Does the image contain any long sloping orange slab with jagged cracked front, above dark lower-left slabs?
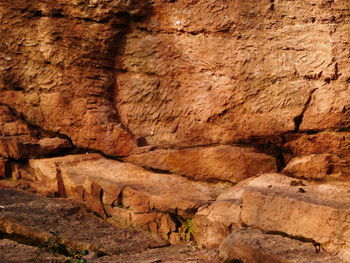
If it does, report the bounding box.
[13,154,222,243]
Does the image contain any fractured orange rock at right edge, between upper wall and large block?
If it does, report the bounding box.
[283,131,350,180]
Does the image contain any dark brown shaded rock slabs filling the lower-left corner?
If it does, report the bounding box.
[0,189,218,263]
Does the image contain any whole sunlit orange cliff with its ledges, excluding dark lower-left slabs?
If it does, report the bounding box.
[0,0,350,263]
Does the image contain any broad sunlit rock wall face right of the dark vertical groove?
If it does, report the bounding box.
[115,0,350,146]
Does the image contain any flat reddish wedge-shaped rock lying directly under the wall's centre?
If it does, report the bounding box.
[126,145,277,183]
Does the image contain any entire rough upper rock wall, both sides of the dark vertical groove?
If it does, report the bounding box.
[0,0,350,156]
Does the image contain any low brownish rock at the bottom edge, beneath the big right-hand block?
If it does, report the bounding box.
[220,229,345,263]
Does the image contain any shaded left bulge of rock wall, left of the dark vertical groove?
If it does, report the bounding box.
[0,0,145,155]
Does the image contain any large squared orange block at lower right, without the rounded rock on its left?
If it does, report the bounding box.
[240,174,350,260]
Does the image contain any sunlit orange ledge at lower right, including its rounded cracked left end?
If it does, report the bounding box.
[194,174,350,260]
